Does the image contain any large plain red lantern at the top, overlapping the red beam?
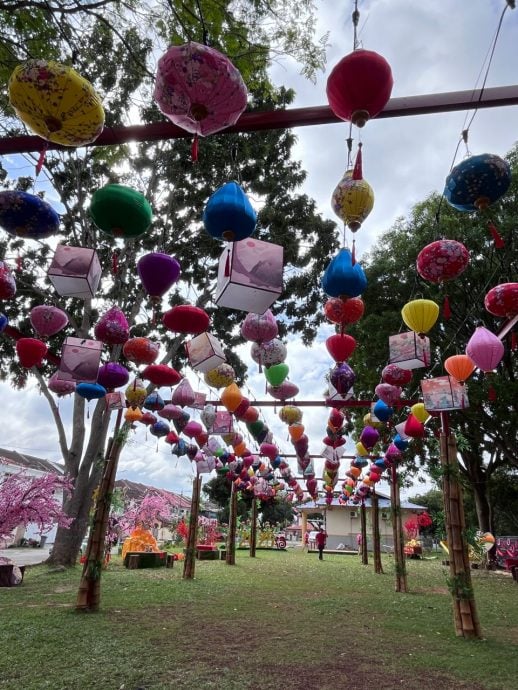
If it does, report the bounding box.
[326,49,394,127]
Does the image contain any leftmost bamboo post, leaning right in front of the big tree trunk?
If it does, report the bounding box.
[76,409,124,611]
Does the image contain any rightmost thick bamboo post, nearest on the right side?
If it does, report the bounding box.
[440,412,482,639]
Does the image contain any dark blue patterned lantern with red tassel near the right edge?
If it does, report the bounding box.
[444,153,511,211]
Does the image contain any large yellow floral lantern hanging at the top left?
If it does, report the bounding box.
[8,60,104,146]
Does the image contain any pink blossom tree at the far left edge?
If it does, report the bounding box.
[0,471,73,539]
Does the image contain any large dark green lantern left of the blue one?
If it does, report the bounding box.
[90,184,153,239]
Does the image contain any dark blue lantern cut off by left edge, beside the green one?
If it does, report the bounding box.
[0,189,59,240]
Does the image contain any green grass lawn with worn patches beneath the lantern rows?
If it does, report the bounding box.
[0,550,518,690]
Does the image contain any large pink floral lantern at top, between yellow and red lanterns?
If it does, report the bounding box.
[153,41,247,136]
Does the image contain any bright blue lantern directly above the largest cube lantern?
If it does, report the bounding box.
[203,182,257,242]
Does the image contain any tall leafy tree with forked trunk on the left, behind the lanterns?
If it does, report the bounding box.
[0,0,336,564]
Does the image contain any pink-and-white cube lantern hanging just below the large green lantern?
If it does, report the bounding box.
[47,244,102,299]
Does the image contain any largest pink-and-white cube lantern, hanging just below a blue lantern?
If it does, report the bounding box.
[215,238,283,314]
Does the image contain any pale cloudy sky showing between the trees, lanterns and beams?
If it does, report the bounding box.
[0,0,518,495]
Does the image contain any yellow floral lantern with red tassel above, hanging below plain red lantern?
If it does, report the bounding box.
[331,149,374,232]
